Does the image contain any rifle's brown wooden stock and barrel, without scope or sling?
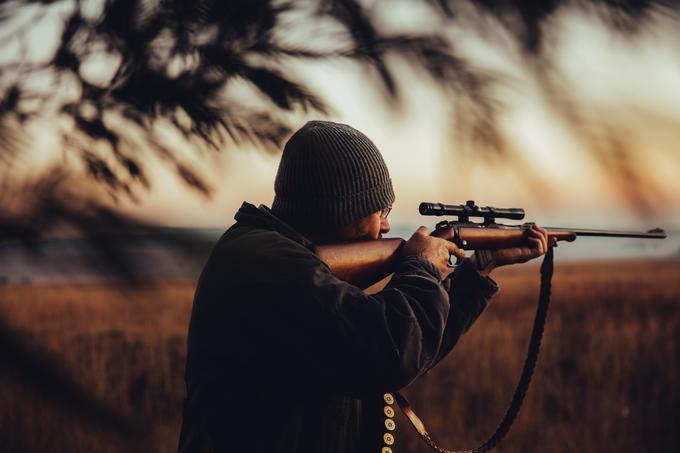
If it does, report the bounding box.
[316,222,666,288]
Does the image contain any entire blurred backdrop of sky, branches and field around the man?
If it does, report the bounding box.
[0,0,680,452]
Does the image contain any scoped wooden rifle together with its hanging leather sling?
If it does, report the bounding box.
[316,201,666,453]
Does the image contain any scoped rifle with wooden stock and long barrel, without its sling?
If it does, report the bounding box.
[316,200,666,288]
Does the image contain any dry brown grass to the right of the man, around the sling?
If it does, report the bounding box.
[400,262,680,453]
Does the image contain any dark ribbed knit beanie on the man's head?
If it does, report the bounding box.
[272,121,394,231]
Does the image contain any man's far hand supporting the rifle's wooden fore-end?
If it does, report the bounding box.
[470,225,555,276]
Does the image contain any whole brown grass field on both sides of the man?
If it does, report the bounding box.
[0,260,680,453]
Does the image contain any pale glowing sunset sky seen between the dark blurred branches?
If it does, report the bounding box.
[0,2,680,237]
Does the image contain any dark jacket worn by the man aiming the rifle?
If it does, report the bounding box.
[180,203,497,453]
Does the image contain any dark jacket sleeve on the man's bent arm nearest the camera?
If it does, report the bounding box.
[298,257,449,395]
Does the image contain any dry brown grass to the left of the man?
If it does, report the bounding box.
[0,281,193,452]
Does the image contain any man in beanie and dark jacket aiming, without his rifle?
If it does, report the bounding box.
[180,121,547,453]
